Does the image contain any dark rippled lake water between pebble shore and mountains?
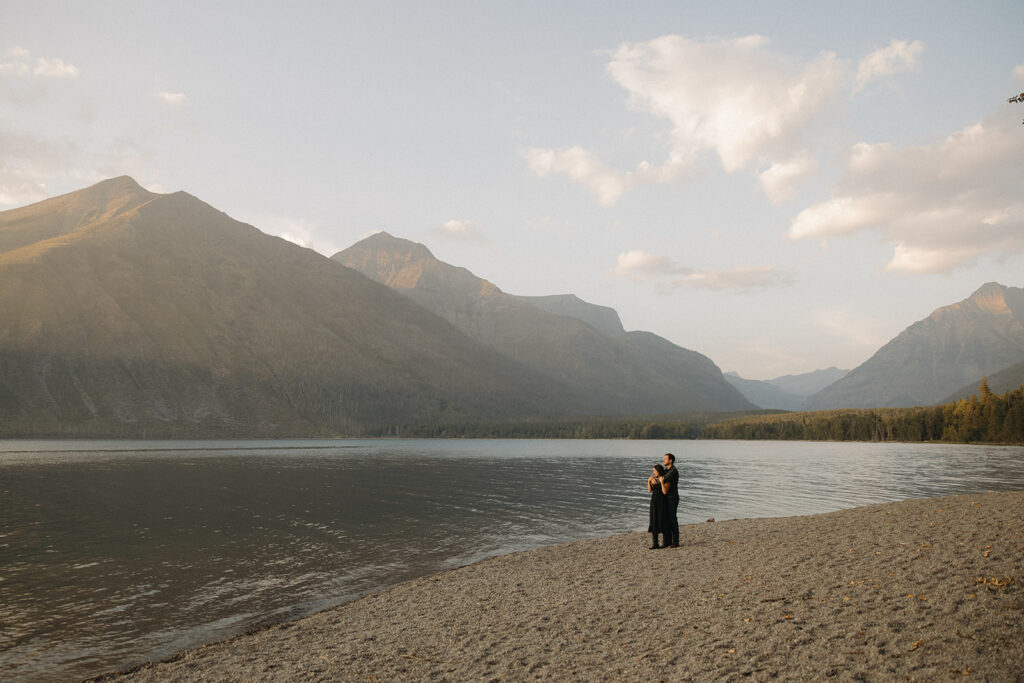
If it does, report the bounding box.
[6,440,1024,681]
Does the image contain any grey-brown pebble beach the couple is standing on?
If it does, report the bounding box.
[97,492,1024,681]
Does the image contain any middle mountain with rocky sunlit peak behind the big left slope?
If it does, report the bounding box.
[332,232,753,415]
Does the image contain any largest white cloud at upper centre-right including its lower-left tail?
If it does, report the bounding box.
[524,36,853,205]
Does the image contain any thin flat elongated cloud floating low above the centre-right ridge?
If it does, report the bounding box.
[612,251,793,291]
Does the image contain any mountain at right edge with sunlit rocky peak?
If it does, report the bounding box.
[804,283,1024,410]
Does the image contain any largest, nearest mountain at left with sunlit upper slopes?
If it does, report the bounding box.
[0,177,585,436]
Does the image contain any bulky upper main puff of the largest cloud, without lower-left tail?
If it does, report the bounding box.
[607,36,849,172]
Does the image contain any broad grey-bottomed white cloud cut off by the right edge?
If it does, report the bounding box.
[790,109,1024,272]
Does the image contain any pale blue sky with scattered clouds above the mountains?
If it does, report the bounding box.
[0,0,1024,379]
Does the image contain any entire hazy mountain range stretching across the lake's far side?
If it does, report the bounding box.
[0,177,1024,437]
